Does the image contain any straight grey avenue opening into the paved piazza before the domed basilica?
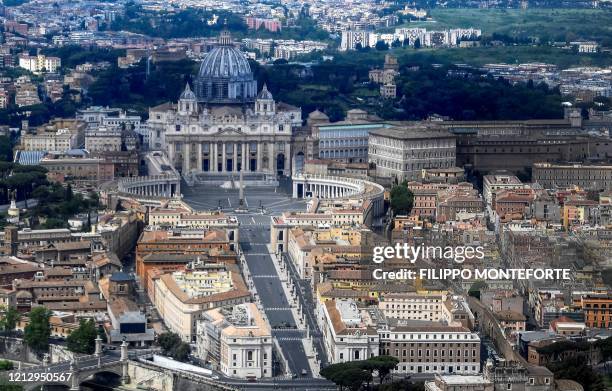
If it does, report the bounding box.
[182,185,330,382]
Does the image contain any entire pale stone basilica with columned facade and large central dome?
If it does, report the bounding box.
[147,31,304,175]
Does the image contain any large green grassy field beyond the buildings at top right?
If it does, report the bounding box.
[405,8,612,46]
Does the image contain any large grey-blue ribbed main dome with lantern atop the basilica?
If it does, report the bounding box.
[194,30,257,103]
